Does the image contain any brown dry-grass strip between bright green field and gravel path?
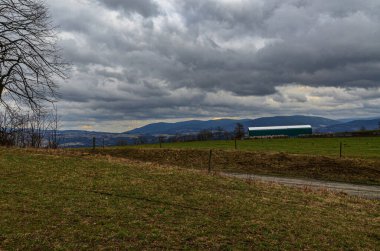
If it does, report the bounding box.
[92,148,380,185]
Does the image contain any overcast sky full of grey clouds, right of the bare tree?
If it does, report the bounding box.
[45,0,380,132]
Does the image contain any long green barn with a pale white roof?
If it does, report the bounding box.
[248,125,313,137]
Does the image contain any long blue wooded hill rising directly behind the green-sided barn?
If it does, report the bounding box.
[126,115,341,135]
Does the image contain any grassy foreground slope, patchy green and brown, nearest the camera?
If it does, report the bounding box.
[0,149,380,250]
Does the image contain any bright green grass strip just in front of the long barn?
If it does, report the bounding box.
[127,137,380,159]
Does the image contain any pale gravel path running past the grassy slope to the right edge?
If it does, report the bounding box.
[221,173,380,200]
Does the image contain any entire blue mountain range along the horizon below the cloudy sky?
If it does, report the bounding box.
[59,115,380,147]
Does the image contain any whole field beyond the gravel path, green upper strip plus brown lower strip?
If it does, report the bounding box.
[92,137,380,185]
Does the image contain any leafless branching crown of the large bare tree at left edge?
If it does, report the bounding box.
[0,0,68,110]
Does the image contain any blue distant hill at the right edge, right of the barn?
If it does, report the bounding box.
[318,118,380,133]
